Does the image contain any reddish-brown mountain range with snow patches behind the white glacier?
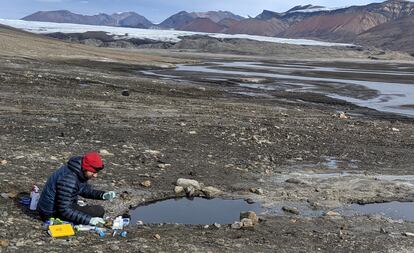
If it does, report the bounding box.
[23,0,414,52]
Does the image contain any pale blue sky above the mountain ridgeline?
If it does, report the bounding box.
[0,0,392,23]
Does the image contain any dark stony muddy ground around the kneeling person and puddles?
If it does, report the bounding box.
[0,26,414,252]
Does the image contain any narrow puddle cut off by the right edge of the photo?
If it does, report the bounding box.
[339,201,414,221]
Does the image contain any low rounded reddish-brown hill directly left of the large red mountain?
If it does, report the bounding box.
[226,18,288,36]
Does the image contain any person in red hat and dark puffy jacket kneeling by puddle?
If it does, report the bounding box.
[37,152,116,226]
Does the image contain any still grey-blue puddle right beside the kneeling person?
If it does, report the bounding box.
[130,198,264,225]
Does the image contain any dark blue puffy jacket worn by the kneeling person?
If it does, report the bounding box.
[38,156,104,224]
